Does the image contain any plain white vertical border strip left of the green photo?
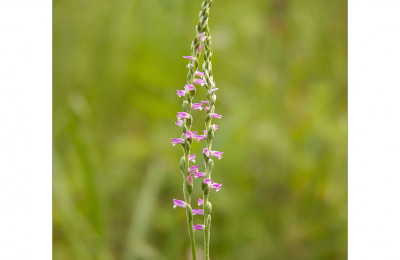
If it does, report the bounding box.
[0,0,52,260]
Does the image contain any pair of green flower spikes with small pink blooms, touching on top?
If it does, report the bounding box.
[171,0,219,259]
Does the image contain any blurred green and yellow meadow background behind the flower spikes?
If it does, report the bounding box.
[53,0,347,260]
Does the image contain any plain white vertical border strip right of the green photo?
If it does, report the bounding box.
[348,0,400,260]
